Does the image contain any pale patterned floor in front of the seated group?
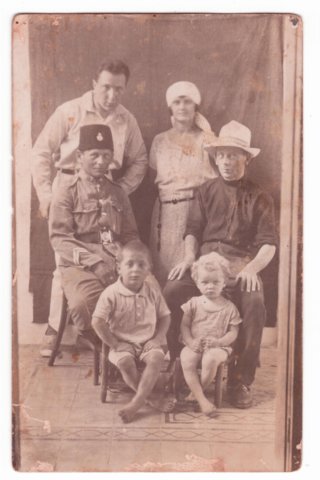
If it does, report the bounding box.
[15,345,276,472]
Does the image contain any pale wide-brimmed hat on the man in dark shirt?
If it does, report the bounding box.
[204,120,260,158]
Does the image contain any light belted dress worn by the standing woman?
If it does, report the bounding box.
[150,130,217,286]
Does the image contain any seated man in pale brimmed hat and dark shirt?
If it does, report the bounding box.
[164,121,277,408]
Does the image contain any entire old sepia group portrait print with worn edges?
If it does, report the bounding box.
[12,13,302,472]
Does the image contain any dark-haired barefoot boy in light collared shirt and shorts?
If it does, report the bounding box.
[92,240,174,422]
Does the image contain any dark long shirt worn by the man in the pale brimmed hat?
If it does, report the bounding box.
[184,177,277,258]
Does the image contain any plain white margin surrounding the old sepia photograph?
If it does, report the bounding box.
[0,0,320,479]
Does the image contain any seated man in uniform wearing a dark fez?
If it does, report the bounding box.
[49,124,138,343]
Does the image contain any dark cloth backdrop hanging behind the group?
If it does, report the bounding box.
[29,14,282,326]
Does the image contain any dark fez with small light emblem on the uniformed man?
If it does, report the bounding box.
[78,125,113,152]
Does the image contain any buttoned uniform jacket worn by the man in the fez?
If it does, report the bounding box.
[49,170,138,269]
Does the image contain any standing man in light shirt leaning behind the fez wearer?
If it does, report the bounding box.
[31,60,147,356]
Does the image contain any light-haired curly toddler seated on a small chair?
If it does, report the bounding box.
[181,252,241,417]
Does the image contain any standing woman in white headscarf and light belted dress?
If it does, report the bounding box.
[150,81,216,286]
